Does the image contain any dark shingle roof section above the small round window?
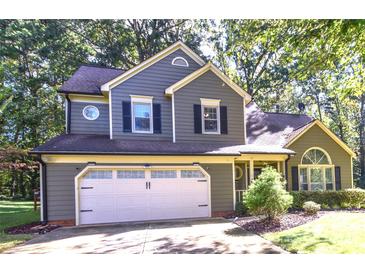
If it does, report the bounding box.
[59,65,124,95]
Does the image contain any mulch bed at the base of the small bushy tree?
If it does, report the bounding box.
[235,211,326,234]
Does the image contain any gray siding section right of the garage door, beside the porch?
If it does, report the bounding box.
[202,164,233,213]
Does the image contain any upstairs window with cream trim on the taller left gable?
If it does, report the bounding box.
[131,95,153,133]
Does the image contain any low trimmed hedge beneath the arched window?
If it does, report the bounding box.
[290,188,365,209]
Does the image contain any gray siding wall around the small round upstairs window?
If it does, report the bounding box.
[71,102,109,135]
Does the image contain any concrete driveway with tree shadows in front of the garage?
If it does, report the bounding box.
[5,219,285,254]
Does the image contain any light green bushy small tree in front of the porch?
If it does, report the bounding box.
[245,166,293,220]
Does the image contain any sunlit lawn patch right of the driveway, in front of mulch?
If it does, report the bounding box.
[264,212,365,254]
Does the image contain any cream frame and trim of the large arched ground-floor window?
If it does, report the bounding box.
[298,147,336,191]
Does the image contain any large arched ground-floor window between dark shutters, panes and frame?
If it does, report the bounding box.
[299,147,335,191]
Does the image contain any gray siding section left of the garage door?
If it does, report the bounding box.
[47,164,85,221]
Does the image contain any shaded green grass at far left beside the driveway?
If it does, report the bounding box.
[0,201,39,253]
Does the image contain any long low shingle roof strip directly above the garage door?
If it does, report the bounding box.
[32,134,294,155]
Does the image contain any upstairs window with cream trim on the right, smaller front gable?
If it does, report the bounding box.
[200,98,221,134]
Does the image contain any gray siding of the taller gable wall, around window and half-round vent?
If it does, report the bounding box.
[111,50,200,140]
